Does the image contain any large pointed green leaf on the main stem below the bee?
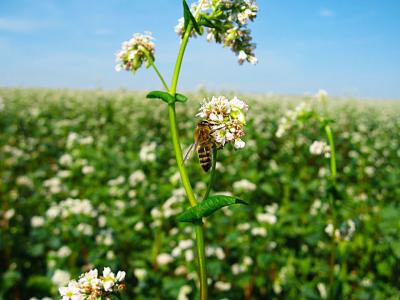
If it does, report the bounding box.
[177,195,247,222]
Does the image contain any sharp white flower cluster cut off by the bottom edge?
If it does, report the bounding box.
[59,268,126,300]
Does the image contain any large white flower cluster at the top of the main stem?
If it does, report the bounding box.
[175,0,258,64]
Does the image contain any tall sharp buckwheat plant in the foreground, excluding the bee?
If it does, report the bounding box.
[116,0,258,300]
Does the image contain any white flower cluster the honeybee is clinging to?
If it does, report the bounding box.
[196,96,249,149]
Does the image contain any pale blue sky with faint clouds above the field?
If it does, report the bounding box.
[0,0,400,99]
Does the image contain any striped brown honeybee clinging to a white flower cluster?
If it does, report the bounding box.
[184,121,224,172]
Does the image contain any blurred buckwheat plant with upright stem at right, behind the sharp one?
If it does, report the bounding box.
[275,90,356,299]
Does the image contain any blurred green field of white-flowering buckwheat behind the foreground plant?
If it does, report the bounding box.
[0,89,400,300]
